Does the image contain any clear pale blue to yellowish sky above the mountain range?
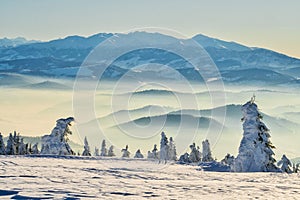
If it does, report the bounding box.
[0,0,300,58]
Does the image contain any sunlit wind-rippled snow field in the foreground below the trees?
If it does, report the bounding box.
[0,156,300,199]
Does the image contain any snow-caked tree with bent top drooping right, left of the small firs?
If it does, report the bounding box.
[41,117,74,155]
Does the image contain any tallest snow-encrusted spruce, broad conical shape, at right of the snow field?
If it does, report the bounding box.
[232,96,279,172]
